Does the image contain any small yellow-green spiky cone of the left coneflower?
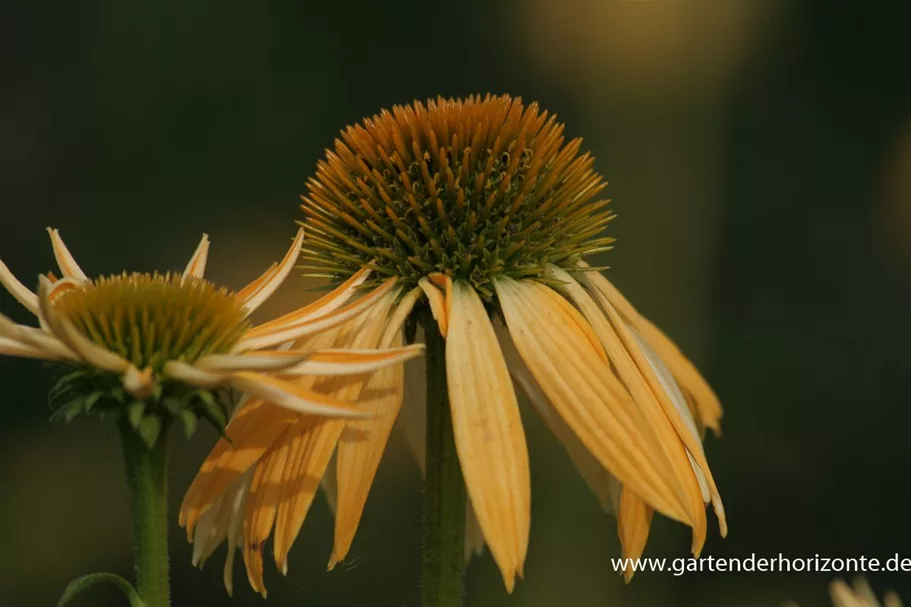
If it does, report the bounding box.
[53,273,247,371]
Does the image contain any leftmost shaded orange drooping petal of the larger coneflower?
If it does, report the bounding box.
[178,399,298,538]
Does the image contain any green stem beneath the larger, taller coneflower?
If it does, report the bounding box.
[421,320,466,607]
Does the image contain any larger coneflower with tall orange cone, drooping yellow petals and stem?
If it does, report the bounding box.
[183,96,726,606]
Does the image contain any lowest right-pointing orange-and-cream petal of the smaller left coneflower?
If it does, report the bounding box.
[230,371,368,417]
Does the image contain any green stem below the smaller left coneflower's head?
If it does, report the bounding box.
[120,424,171,607]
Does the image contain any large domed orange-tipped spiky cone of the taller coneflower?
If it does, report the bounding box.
[302,96,613,299]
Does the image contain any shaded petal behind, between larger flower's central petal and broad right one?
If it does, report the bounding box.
[494,322,619,512]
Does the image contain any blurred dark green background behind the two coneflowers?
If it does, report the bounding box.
[0,0,911,607]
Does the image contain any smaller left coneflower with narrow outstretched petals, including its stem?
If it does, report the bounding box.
[0,229,420,607]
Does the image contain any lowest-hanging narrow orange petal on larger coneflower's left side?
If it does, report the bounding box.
[243,424,296,598]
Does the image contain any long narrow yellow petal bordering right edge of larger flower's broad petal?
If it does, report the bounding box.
[548,266,707,555]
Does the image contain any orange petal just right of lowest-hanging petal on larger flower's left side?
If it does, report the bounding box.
[272,417,345,574]
